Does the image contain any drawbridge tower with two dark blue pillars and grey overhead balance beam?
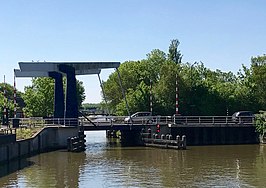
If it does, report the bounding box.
[14,62,120,126]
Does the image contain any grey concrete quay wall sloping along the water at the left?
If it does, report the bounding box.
[0,126,79,163]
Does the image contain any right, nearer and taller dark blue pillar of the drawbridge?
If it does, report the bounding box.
[59,65,78,126]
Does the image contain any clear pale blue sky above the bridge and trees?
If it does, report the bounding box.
[0,0,266,103]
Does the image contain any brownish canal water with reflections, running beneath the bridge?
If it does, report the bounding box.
[0,131,266,187]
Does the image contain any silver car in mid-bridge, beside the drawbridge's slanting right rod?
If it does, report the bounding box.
[124,112,152,124]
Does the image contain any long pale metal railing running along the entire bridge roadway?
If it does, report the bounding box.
[2,115,255,129]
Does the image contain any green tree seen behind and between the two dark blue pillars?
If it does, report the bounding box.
[23,78,85,117]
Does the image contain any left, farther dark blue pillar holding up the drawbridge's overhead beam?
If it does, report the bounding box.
[49,72,65,119]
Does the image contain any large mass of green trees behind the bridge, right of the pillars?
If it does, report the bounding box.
[101,40,266,116]
